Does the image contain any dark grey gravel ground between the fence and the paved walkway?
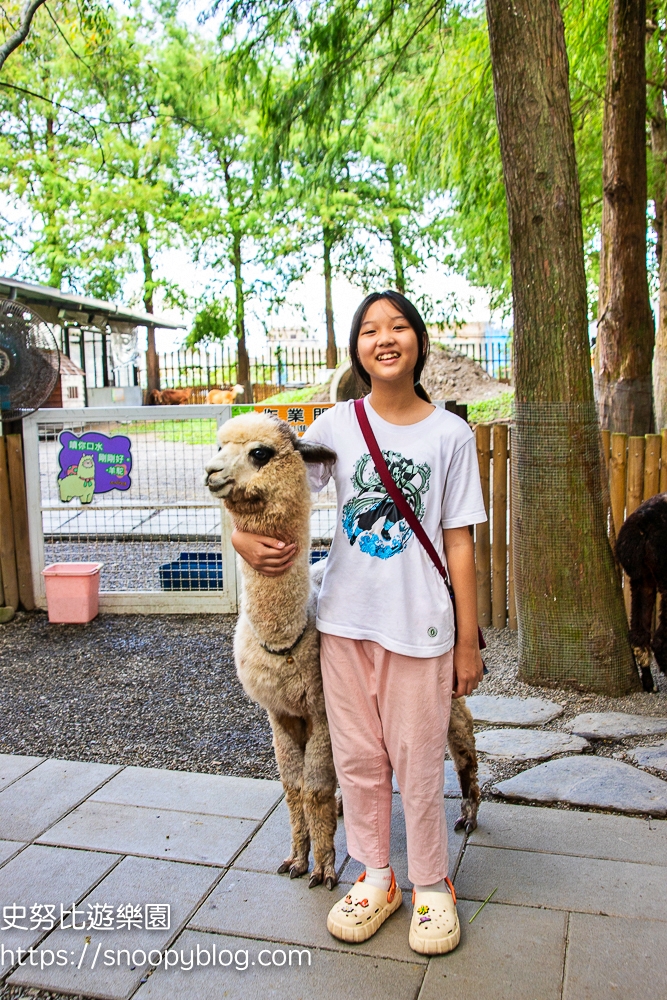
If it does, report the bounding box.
[0,613,667,1000]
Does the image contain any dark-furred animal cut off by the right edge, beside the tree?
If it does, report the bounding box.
[616,493,667,691]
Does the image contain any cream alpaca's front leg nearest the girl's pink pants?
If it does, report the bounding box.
[303,717,338,889]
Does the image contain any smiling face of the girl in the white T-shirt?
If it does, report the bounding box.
[357,299,419,382]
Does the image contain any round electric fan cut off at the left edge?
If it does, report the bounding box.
[0,298,60,421]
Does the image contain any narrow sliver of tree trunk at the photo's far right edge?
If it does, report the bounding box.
[650,32,667,430]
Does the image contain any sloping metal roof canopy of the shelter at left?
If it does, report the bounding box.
[0,276,184,330]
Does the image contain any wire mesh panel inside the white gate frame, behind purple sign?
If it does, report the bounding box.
[38,418,223,591]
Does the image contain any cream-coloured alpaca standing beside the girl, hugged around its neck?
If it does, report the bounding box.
[206,414,479,889]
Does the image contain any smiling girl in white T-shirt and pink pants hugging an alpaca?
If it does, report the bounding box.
[233,291,486,954]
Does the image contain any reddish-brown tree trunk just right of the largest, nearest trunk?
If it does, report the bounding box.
[595,0,654,434]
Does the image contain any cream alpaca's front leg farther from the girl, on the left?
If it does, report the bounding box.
[269,712,310,878]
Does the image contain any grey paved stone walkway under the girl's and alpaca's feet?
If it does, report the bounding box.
[0,755,667,1000]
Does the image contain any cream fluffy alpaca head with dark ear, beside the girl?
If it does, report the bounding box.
[205,413,336,512]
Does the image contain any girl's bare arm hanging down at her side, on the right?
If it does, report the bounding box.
[442,527,483,698]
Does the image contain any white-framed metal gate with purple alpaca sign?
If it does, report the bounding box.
[23,405,237,614]
